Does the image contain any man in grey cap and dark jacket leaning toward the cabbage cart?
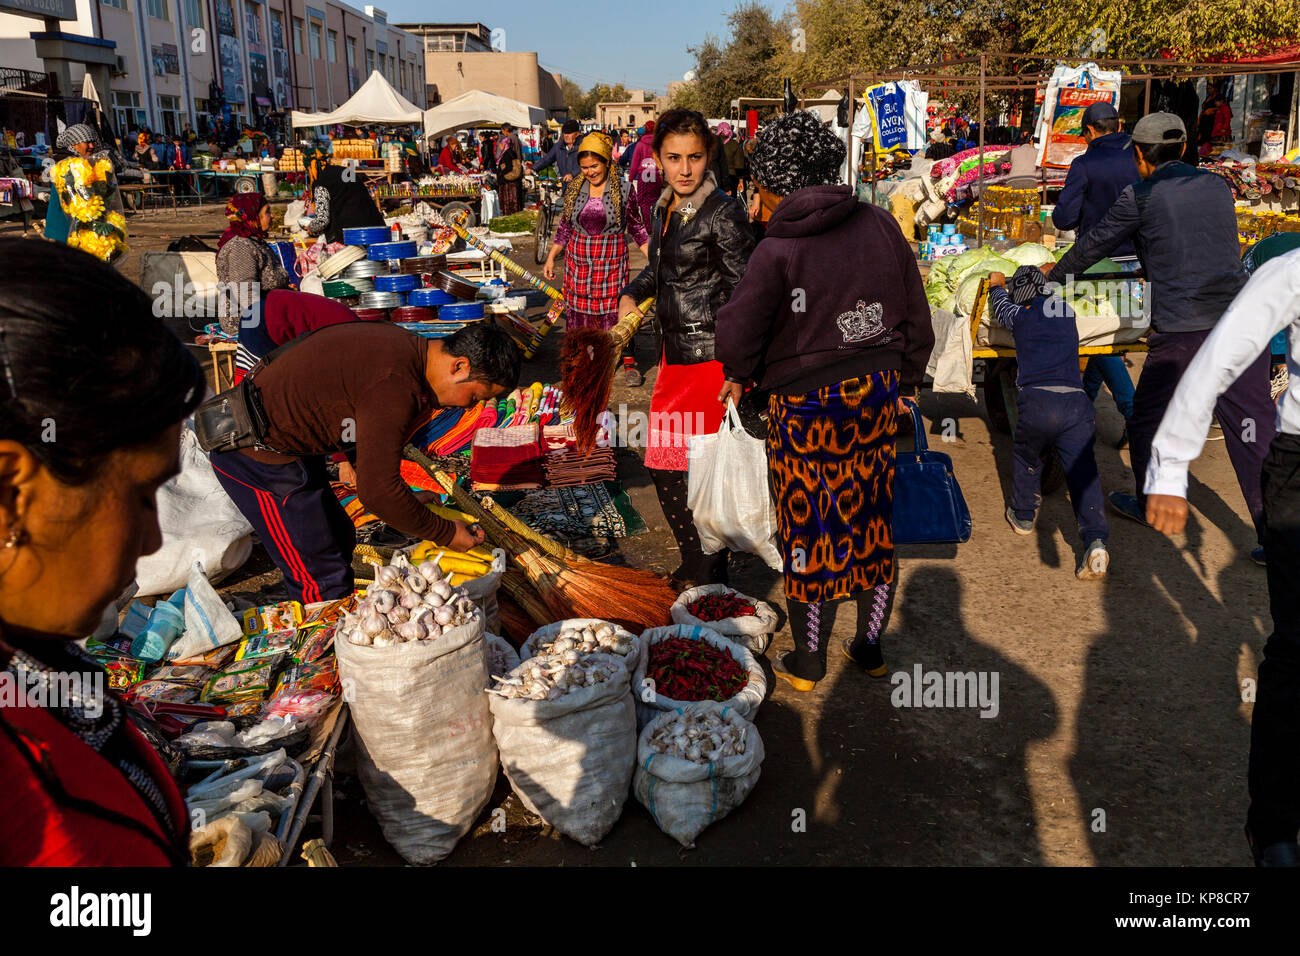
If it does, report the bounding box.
[1043,113,1275,563]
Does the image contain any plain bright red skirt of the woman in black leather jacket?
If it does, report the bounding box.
[646,352,724,471]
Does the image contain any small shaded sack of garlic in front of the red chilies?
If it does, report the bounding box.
[632,701,763,849]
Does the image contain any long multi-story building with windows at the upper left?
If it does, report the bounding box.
[0,0,426,140]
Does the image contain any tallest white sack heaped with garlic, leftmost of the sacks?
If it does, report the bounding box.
[334,564,497,865]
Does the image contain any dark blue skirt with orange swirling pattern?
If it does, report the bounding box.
[767,372,898,604]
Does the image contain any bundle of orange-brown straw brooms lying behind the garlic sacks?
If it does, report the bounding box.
[404,445,677,633]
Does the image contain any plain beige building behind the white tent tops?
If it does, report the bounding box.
[398,23,567,116]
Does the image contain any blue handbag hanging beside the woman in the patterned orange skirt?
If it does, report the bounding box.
[893,406,971,545]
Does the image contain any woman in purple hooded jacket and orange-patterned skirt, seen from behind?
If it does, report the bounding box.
[716,112,935,691]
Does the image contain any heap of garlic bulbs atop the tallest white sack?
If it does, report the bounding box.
[338,554,476,648]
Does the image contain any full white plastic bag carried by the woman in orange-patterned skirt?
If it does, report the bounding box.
[686,402,785,571]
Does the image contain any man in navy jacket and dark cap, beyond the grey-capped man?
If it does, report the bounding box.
[1052,103,1141,447]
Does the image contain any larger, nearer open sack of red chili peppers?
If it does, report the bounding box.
[632,624,767,727]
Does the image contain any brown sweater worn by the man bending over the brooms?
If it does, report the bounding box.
[244,323,455,544]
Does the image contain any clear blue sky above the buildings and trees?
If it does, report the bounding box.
[379,0,775,92]
